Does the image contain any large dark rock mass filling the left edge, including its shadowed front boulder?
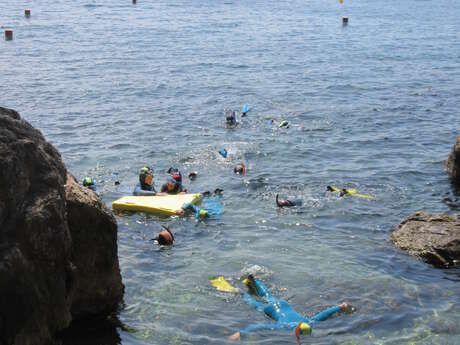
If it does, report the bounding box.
[0,107,123,345]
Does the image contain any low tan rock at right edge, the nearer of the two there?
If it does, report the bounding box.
[391,212,460,267]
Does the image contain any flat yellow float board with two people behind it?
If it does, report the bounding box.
[112,193,203,216]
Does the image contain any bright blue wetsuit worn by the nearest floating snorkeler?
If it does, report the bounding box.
[240,279,340,335]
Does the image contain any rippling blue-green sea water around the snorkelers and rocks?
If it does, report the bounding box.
[0,0,460,345]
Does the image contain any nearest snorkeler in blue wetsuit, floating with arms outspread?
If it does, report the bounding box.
[228,275,353,343]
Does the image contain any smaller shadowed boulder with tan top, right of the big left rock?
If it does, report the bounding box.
[65,174,123,319]
